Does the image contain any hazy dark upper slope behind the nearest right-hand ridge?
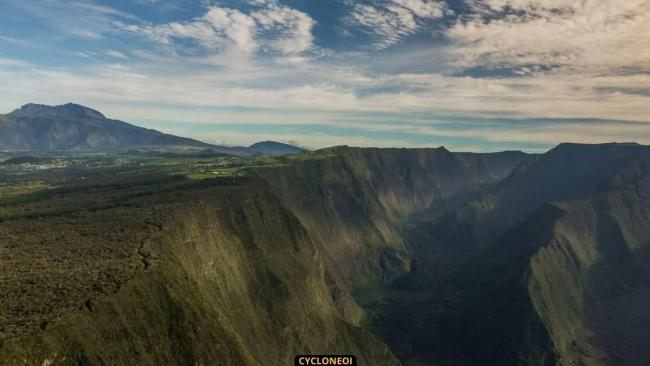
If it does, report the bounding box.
[432,144,650,256]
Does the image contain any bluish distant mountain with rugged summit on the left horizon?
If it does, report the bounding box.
[0,103,252,155]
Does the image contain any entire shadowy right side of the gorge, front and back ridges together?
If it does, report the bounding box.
[372,144,650,365]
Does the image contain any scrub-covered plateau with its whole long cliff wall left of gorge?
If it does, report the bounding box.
[0,148,526,365]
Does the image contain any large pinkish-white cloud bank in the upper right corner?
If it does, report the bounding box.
[447,0,650,73]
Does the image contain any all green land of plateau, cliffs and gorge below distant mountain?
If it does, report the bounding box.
[0,145,650,365]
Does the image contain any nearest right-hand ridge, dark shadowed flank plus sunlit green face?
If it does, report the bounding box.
[459,154,650,365]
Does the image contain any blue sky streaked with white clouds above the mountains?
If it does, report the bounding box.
[0,0,650,152]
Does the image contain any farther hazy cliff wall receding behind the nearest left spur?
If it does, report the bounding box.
[253,148,529,286]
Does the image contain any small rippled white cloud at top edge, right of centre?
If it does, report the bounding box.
[351,0,445,49]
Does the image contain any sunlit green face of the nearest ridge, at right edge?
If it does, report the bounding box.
[528,155,650,365]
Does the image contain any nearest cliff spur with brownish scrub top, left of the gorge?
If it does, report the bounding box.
[0,182,397,365]
